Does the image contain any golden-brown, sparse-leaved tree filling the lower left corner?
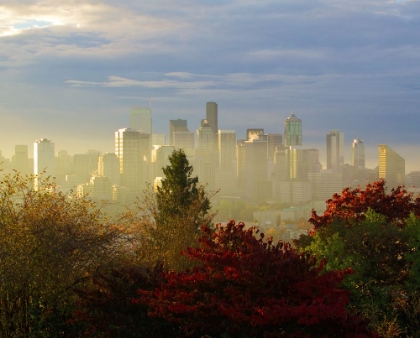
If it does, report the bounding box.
[0,173,123,337]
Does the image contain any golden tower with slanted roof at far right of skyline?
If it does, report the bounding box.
[379,144,405,189]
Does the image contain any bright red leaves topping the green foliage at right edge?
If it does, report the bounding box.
[309,179,420,229]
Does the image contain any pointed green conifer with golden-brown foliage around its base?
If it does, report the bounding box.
[132,150,214,270]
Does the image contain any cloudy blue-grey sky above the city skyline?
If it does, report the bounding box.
[0,0,420,172]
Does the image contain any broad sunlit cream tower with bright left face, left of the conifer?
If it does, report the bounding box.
[115,128,148,201]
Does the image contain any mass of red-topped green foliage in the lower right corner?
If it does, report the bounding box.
[296,180,420,337]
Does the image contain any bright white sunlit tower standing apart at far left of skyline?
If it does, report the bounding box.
[34,138,55,176]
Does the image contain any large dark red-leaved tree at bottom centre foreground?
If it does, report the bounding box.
[135,221,373,337]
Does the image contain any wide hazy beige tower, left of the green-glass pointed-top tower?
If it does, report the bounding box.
[244,139,272,201]
